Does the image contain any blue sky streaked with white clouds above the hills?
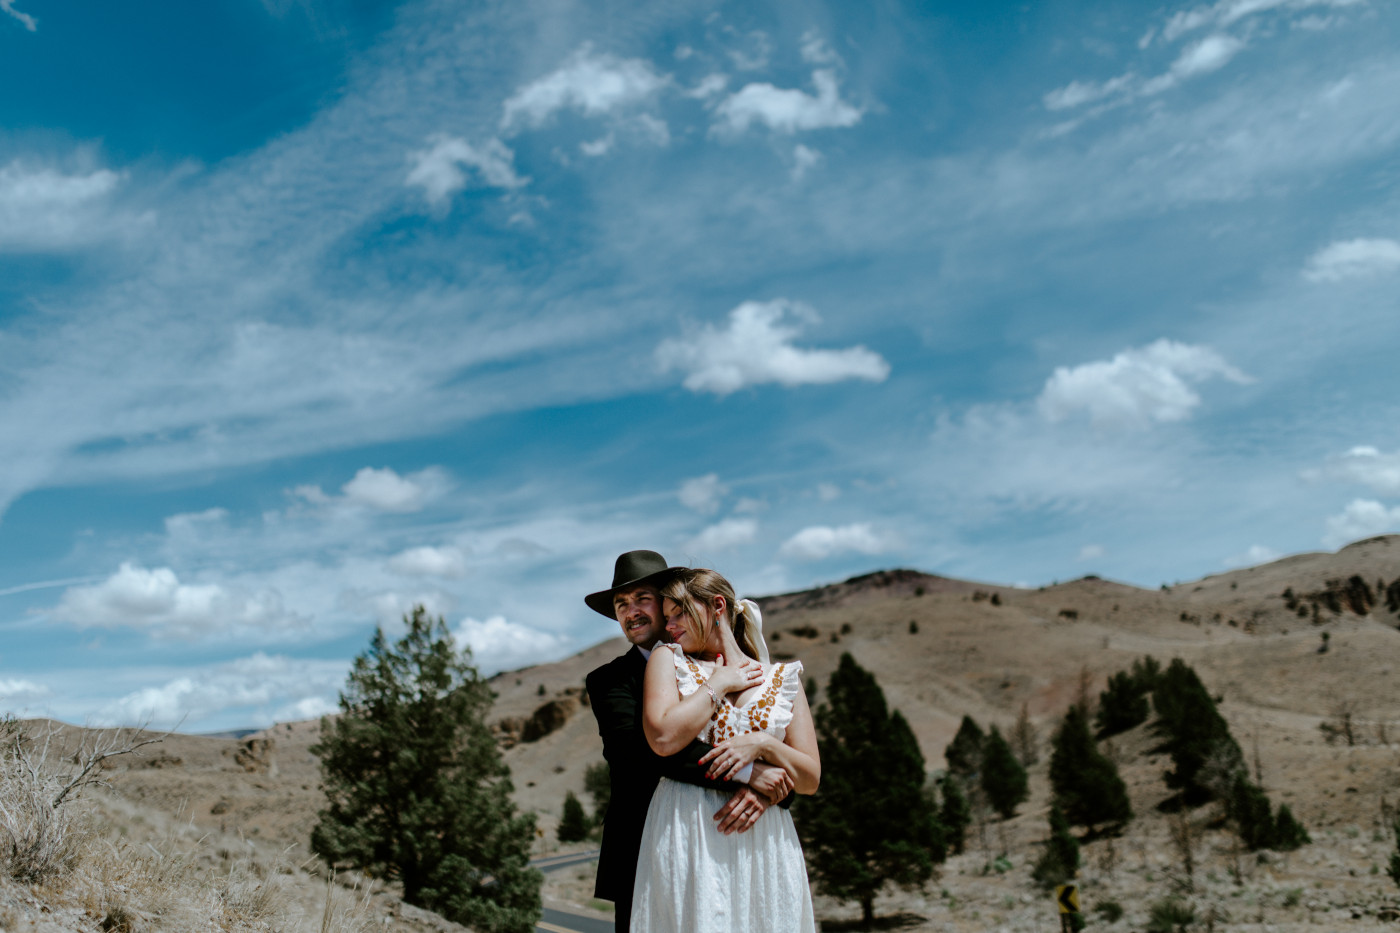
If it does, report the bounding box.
[0,0,1400,730]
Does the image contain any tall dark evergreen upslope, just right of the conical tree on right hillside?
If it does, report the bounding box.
[1152,658,1245,800]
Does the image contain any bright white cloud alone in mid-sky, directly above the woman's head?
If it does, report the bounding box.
[657,298,889,395]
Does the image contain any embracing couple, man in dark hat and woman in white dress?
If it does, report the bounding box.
[584,551,822,933]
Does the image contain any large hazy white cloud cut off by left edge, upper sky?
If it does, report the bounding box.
[0,161,122,252]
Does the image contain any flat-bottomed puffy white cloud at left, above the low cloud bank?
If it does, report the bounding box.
[52,563,307,639]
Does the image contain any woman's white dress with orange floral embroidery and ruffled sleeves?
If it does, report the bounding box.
[631,646,816,933]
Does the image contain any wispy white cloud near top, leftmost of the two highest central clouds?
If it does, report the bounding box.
[501,45,671,132]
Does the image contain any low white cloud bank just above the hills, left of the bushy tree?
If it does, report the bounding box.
[95,651,349,728]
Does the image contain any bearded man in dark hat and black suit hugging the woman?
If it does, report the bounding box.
[584,551,791,933]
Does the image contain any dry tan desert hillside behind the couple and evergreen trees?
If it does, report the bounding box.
[8,537,1400,930]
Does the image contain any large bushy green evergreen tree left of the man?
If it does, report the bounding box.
[311,607,540,933]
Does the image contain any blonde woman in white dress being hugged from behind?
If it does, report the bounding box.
[631,570,822,933]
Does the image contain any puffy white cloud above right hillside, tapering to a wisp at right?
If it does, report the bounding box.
[1036,340,1249,426]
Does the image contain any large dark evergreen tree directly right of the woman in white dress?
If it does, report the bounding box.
[794,654,946,926]
